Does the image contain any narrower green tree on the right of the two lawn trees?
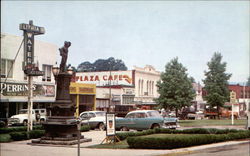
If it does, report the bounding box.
[203,53,231,118]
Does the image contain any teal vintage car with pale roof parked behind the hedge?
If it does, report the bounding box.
[116,110,178,131]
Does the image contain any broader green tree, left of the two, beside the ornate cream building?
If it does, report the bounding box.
[155,58,195,116]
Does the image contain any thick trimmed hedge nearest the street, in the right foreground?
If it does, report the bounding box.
[127,131,250,149]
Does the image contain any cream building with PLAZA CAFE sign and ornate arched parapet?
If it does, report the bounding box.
[75,65,160,111]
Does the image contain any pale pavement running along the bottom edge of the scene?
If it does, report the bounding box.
[0,127,249,156]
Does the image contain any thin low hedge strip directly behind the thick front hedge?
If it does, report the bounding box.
[116,128,244,140]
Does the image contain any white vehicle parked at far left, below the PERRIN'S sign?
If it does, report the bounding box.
[8,109,46,126]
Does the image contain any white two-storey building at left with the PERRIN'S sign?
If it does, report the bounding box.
[0,34,58,118]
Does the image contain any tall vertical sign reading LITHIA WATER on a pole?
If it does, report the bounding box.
[19,21,45,76]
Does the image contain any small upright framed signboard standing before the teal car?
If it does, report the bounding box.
[106,113,115,136]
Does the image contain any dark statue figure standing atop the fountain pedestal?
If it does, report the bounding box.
[59,41,71,72]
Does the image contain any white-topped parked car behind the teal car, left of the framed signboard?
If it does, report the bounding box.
[79,111,106,130]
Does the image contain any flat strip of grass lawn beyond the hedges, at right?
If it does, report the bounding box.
[179,119,247,127]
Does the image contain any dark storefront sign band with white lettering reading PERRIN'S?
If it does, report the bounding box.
[0,82,55,97]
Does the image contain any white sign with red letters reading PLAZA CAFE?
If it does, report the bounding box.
[75,71,134,86]
